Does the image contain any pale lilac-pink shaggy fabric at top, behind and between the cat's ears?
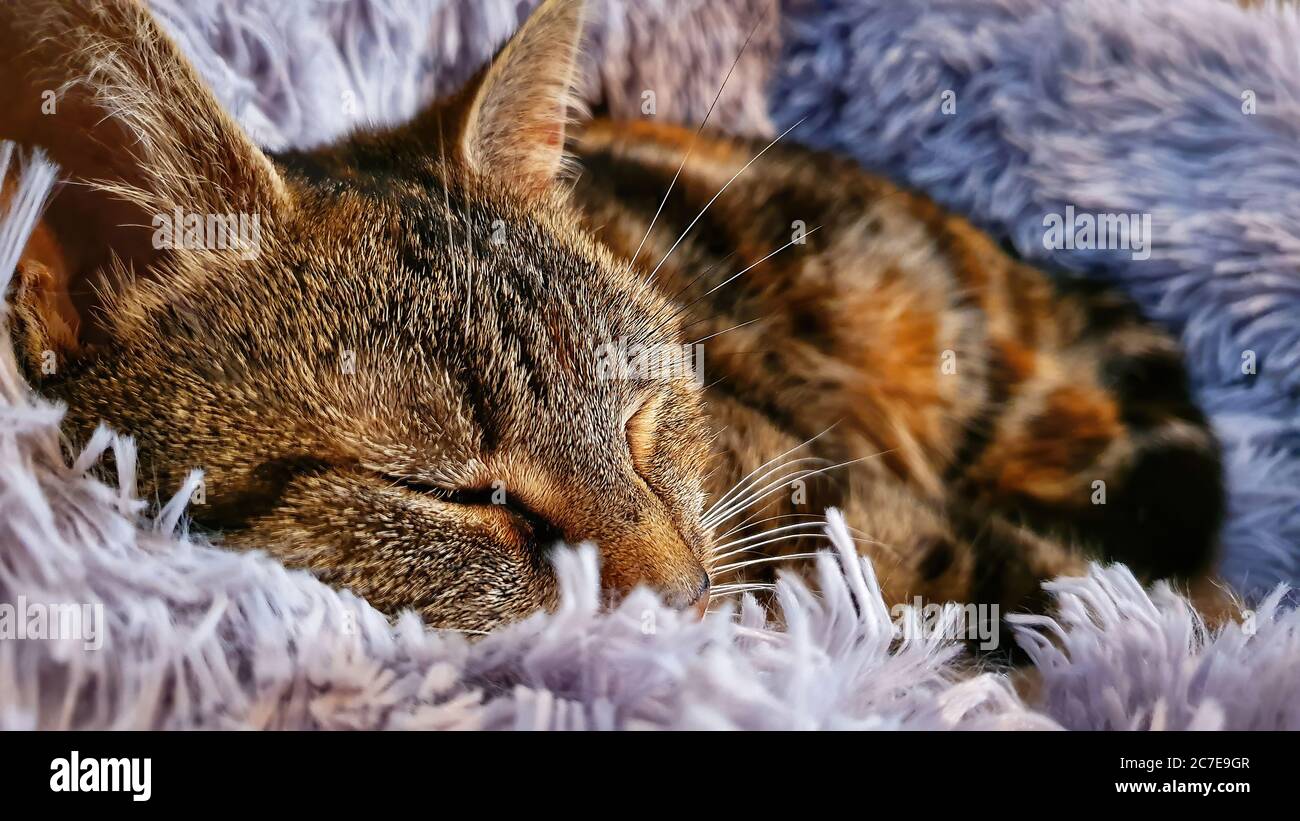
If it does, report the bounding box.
[150,0,780,149]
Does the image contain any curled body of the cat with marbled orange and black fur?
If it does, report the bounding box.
[573,121,1222,609]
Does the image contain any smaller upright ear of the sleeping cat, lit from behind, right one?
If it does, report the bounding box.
[456,0,584,192]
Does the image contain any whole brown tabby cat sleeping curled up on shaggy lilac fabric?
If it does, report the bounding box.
[0,0,1222,630]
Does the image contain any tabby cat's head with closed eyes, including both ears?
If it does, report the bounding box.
[0,0,710,630]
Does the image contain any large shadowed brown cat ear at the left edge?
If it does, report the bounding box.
[0,0,286,366]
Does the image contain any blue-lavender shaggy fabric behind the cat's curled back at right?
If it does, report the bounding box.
[772,0,1300,598]
